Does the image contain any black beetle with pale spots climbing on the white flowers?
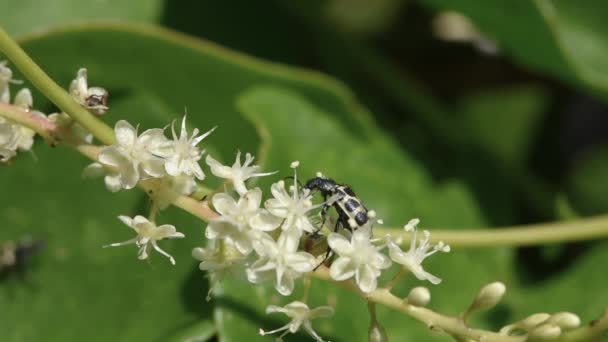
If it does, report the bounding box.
[303,175,376,231]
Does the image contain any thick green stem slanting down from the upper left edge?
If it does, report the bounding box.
[0,27,116,145]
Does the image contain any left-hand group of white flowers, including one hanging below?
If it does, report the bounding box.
[95,115,213,264]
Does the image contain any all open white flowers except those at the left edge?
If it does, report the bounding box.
[59,65,449,341]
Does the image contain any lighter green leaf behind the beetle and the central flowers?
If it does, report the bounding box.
[217,86,510,341]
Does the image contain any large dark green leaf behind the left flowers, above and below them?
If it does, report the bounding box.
[0,24,378,341]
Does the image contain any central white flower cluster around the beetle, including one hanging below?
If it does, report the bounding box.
[193,159,449,341]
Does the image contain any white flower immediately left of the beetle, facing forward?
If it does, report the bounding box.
[264,162,324,233]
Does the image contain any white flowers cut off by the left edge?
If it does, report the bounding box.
[0,62,45,162]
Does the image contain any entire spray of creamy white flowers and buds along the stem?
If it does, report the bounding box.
[0,62,600,341]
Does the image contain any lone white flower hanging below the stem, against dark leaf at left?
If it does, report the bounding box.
[103,215,184,265]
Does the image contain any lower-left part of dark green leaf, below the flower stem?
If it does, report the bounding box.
[0,145,211,341]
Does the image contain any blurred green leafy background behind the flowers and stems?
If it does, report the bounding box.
[0,0,608,341]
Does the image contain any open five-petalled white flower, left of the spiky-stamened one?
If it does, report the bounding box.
[98,120,167,189]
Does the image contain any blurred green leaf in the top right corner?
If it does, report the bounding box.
[421,0,608,98]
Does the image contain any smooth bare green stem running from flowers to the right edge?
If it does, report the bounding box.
[374,215,608,248]
